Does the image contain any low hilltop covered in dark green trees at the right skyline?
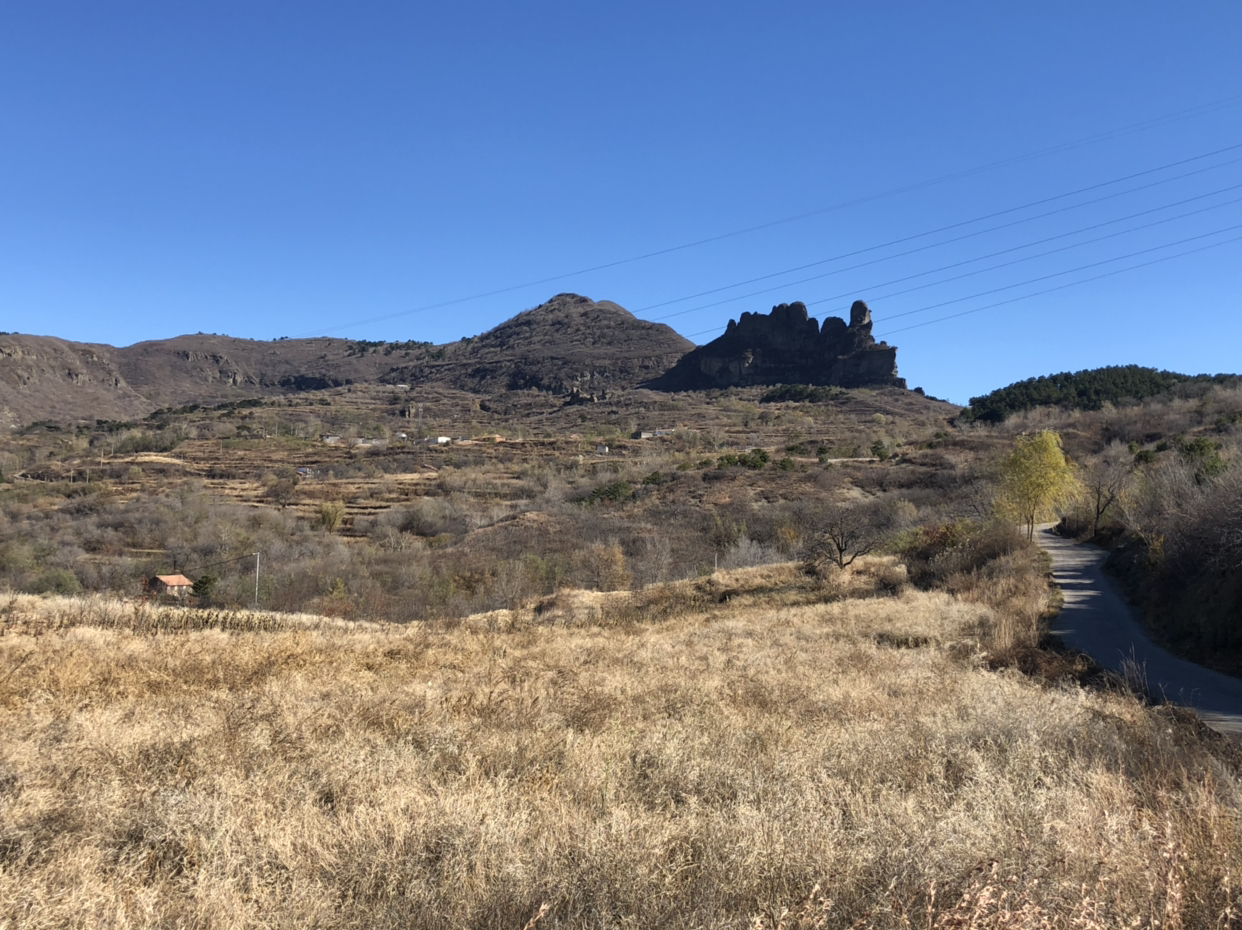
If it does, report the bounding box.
[961,365,1240,423]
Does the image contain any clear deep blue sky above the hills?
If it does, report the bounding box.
[0,0,1242,401]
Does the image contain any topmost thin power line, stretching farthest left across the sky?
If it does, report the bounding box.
[294,94,1242,339]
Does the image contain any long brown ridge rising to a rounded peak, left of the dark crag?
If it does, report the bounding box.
[0,294,694,428]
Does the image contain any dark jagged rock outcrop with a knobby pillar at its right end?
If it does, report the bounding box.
[648,300,905,391]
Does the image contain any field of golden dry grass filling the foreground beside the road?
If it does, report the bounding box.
[0,566,1242,929]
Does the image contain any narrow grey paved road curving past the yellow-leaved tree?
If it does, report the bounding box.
[1036,526,1242,740]
